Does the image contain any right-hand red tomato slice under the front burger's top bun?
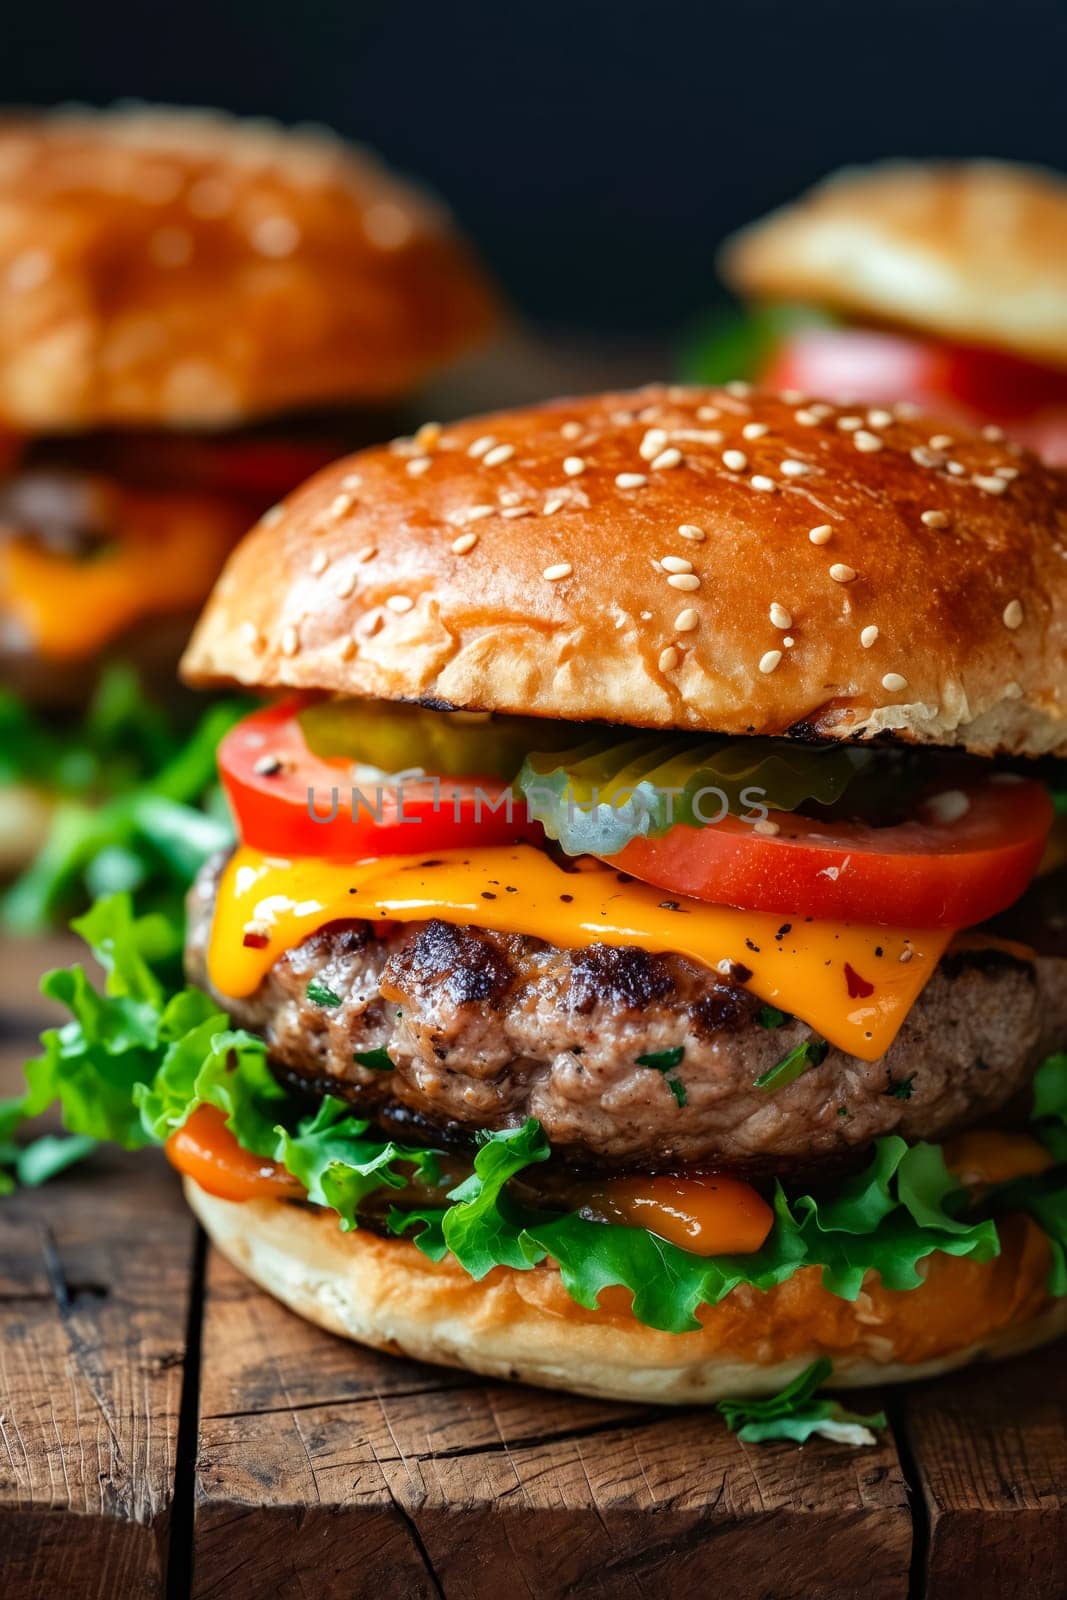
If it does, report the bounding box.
[611,778,1053,928]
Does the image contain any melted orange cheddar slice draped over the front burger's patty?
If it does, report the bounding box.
[208,845,952,1061]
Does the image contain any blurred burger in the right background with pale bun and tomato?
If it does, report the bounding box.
[697,162,1067,464]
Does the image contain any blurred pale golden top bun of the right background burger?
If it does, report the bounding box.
[720,162,1067,366]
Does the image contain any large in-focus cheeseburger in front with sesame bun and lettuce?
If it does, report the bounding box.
[18,384,1067,1402]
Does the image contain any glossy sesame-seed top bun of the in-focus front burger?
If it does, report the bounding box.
[184,386,1067,754]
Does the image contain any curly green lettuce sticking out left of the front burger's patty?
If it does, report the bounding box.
[0,894,438,1227]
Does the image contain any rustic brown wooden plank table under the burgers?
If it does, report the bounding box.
[0,942,1067,1600]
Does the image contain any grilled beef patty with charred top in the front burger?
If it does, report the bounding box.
[187,862,1067,1171]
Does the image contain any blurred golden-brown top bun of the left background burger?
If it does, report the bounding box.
[0,110,491,430]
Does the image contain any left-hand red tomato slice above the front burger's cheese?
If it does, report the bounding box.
[219,701,544,861]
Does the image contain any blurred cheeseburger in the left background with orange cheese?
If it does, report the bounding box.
[0,110,491,920]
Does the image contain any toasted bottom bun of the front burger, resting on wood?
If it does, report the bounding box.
[186,1178,1067,1405]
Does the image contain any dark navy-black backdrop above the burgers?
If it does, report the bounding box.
[0,0,1067,331]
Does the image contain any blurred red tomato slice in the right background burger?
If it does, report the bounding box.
[763,328,1067,461]
